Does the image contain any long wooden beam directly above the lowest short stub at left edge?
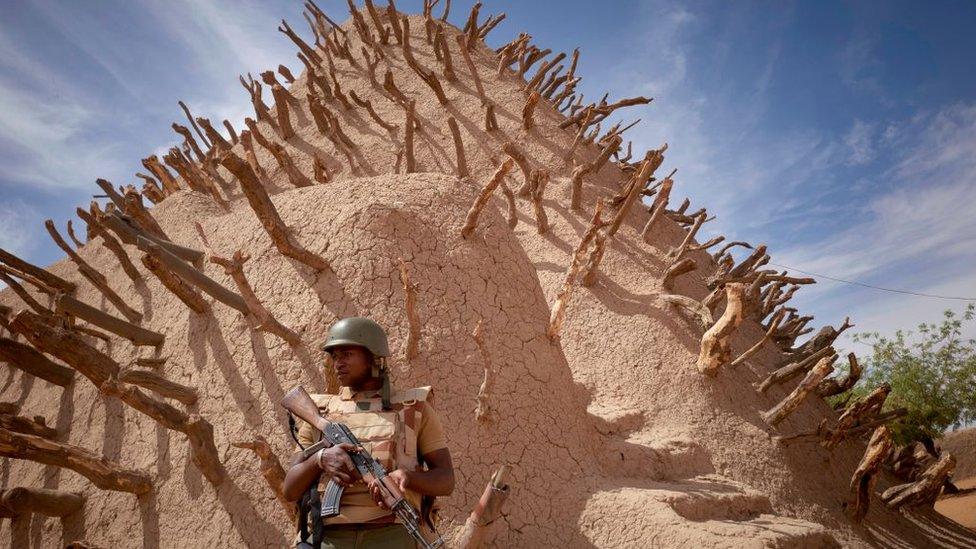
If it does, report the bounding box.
[0,429,152,494]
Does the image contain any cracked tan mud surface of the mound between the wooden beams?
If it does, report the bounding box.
[0,4,976,547]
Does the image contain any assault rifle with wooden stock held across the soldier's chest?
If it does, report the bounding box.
[281,385,444,549]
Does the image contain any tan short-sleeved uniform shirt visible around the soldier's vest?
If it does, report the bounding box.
[297,387,447,524]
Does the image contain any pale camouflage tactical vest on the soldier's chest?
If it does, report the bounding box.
[311,387,432,524]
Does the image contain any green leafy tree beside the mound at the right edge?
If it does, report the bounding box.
[840,303,976,444]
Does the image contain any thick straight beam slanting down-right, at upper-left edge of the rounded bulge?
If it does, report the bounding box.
[215,151,329,272]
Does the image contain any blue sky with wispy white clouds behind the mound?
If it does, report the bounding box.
[0,0,976,346]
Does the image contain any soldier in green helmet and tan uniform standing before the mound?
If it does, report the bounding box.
[282,317,454,549]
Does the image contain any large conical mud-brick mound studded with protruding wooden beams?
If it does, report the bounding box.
[0,3,976,547]
